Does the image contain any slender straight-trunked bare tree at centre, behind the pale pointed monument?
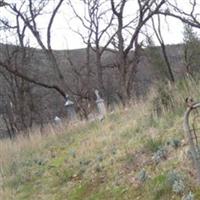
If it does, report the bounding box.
[68,0,115,97]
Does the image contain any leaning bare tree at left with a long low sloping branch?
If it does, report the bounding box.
[1,0,72,98]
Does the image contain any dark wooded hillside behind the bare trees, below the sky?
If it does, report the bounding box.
[0,44,185,138]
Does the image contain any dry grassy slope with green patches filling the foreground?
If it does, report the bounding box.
[0,79,200,200]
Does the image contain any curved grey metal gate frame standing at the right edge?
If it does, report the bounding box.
[183,103,200,184]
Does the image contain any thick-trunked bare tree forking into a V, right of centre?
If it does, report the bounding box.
[110,0,165,105]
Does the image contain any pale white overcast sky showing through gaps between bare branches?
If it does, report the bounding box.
[0,0,198,49]
